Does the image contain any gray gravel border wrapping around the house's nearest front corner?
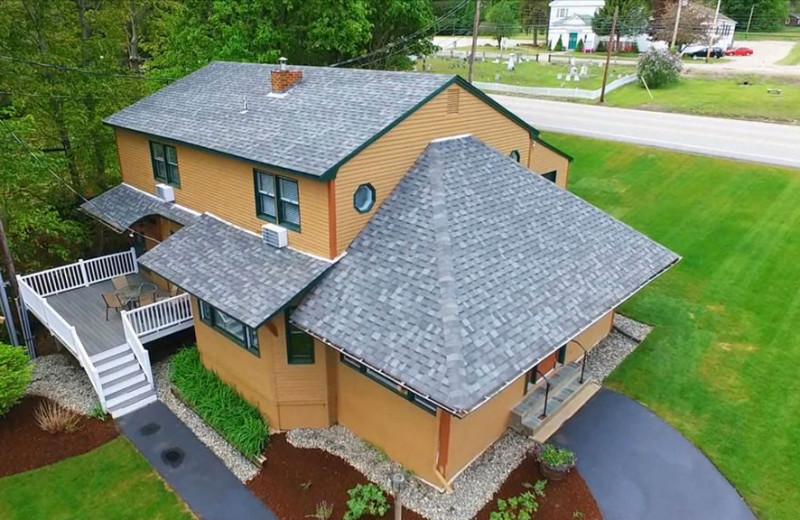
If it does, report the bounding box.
[286,425,535,520]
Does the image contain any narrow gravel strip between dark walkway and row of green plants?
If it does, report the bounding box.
[153,357,260,482]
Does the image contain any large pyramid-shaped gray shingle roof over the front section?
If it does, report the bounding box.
[291,137,678,413]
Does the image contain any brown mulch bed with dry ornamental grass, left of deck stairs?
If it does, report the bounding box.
[0,395,119,477]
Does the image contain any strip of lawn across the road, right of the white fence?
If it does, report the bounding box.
[606,77,800,122]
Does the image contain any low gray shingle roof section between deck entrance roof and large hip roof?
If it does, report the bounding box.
[139,214,333,327]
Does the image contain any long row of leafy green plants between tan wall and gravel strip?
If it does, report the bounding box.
[169,347,269,457]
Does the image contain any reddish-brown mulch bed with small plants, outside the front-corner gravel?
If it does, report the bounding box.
[247,434,602,520]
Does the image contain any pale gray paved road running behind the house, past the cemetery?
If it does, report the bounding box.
[492,95,800,168]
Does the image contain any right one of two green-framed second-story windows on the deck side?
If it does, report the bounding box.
[255,170,300,231]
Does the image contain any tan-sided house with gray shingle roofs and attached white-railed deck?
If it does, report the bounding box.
[15,62,678,489]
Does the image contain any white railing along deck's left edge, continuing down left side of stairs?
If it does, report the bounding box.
[17,276,106,410]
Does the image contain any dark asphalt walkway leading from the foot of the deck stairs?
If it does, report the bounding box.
[117,401,278,520]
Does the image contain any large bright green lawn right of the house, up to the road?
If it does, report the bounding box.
[546,135,800,520]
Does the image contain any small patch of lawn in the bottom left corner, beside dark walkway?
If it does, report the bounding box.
[0,438,194,520]
